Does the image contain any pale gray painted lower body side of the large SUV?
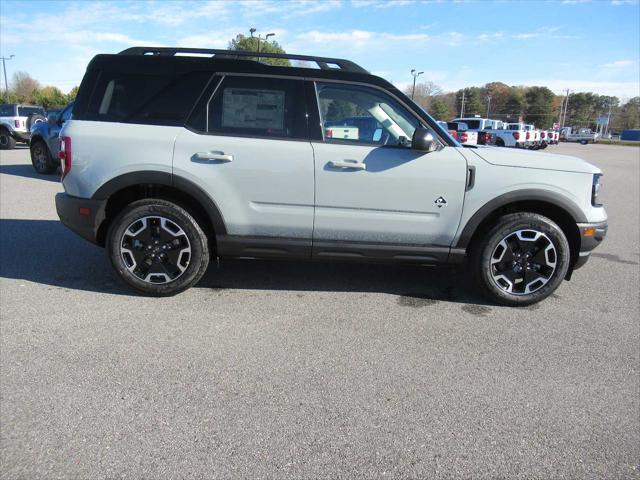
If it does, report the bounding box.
[61,113,607,246]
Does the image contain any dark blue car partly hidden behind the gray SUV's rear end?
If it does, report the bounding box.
[29,102,73,174]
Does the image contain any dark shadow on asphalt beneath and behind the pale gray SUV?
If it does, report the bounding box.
[0,219,487,307]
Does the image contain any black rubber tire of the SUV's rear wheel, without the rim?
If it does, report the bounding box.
[106,200,209,296]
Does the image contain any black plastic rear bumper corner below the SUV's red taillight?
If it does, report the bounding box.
[56,193,107,244]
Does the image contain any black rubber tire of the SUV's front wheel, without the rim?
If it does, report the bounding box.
[475,213,570,306]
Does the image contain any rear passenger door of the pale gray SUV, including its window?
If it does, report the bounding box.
[173,74,314,256]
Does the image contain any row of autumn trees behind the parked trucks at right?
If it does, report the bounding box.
[404,82,640,131]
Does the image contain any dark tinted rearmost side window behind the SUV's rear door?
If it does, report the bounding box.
[86,72,211,126]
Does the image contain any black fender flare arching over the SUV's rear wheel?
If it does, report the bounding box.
[91,171,227,235]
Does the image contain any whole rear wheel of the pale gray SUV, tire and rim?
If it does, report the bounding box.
[106,199,209,297]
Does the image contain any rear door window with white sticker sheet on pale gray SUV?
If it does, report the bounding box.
[206,75,308,140]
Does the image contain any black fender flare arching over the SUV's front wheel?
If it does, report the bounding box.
[453,188,587,249]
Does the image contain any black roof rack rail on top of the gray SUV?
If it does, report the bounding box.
[119,47,369,73]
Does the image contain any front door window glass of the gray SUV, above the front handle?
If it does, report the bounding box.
[316,82,420,146]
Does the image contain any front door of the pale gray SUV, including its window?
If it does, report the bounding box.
[312,82,467,259]
